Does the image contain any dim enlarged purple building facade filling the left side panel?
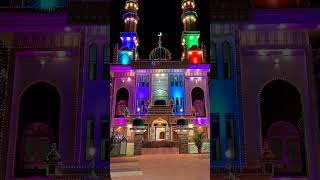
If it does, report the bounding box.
[0,0,110,180]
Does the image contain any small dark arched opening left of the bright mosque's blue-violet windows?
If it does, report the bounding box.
[115,88,129,117]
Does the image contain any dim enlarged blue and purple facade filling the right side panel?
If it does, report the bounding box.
[210,0,320,179]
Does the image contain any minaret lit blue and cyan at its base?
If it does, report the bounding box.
[116,0,139,65]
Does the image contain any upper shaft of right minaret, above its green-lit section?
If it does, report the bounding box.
[181,0,198,31]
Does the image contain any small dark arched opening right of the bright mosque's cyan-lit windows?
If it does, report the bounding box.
[191,87,206,117]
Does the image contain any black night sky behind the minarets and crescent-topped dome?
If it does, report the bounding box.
[111,0,210,60]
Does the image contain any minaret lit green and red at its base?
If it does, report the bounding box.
[181,0,205,64]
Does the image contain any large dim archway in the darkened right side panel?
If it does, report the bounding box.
[260,80,306,175]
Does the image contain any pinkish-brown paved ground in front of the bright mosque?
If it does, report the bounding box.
[111,148,210,180]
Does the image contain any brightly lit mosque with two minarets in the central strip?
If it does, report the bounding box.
[110,0,210,154]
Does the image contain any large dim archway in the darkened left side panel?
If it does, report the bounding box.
[15,82,60,177]
